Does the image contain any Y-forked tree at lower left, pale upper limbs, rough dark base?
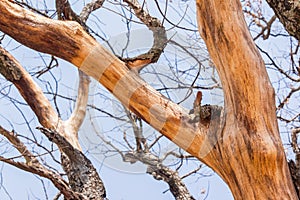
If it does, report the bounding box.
[0,41,105,199]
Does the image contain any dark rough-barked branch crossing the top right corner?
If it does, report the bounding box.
[267,0,300,41]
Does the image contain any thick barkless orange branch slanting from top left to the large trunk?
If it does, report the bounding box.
[0,0,207,159]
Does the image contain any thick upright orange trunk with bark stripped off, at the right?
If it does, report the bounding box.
[197,0,298,200]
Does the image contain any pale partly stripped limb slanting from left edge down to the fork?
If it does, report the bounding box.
[0,47,87,149]
